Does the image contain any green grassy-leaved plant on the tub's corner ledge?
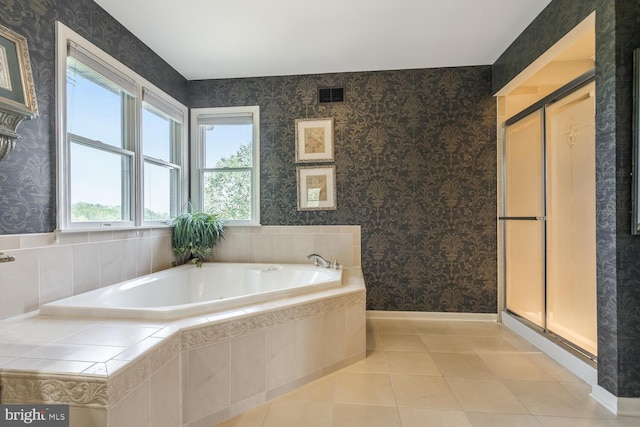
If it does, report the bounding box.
[171,208,224,267]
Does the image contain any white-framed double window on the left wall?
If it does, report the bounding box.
[57,23,187,230]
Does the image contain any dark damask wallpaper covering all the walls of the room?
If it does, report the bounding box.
[0,0,640,397]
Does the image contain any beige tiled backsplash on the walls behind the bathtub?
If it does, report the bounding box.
[0,226,360,319]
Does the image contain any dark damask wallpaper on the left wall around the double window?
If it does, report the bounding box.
[0,0,187,234]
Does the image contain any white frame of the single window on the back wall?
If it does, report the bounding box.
[191,106,260,226]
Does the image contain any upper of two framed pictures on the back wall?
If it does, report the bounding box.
[296,118,334,162]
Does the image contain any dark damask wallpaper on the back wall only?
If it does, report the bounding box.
[189,66,497,313]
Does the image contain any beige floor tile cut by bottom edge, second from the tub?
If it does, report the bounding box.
[261,400,333,427]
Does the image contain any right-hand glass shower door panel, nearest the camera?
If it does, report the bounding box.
[546,83,597,355]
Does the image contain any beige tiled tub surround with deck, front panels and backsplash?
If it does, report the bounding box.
[0,226,366,427]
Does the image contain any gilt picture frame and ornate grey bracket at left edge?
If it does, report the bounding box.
[0,25,38,161]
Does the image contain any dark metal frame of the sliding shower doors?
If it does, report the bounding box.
[498,69,598,363]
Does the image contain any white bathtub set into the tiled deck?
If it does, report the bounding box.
[40,263,342,319]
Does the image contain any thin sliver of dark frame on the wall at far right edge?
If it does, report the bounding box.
[631,48,640,235]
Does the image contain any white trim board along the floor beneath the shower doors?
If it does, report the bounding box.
[502,312,598,386]
